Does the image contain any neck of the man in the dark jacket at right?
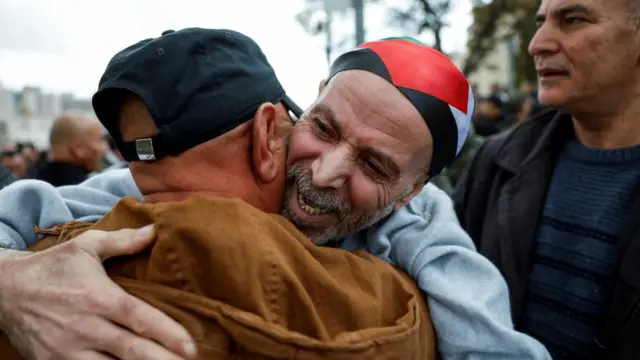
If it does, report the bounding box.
[573,91,640,149]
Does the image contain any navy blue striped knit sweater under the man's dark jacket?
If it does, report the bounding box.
[519,140,640,360]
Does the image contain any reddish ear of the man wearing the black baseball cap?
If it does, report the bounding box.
[252,103,282,183]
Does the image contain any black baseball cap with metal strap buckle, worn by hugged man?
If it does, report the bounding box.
[92,28,302,161]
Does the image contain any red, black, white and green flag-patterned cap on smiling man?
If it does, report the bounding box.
[327,37,474,177]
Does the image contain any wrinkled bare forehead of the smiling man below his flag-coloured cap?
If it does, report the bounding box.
[308,71,432,173]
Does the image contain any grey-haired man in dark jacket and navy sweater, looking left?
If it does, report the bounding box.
[454,0,640,360]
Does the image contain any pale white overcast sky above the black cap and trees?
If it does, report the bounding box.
[0,0,470,107]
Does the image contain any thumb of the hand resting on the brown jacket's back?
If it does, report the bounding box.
[74,225,156,261]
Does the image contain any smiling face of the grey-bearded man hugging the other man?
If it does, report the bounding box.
[283,70,432,244]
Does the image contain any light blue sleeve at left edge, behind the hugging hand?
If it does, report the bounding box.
[0,169,141,250]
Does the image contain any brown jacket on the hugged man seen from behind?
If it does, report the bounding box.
[0,195,437,360]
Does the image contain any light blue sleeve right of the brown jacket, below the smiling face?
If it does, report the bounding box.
[346,184,551,360]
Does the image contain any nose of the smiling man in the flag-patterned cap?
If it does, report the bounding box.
[311,145,354,189]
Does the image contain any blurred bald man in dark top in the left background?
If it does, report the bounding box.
[36,114,107,186]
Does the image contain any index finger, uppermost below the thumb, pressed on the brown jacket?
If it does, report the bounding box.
[106,291,196,359]
